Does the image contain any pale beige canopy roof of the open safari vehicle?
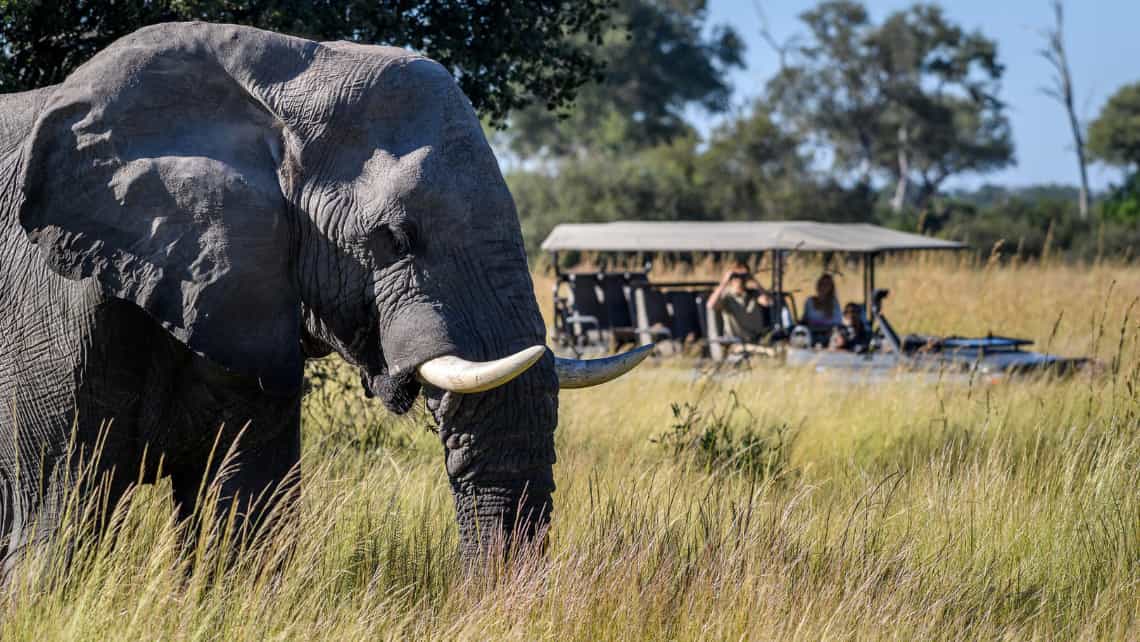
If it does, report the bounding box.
[543,221,967,254]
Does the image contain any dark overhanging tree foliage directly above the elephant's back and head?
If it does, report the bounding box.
[0,0,612,124]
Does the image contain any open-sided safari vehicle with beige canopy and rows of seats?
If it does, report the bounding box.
[543,221,1085,379]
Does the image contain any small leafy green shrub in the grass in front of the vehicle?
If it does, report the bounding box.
[653,390,796,479]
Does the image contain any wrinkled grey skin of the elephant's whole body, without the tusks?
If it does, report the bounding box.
[0,23,557,563]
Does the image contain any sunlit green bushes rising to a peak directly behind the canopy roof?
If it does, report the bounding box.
[506,104,874,253]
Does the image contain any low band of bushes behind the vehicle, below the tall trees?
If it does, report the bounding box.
[507,145,1140,260]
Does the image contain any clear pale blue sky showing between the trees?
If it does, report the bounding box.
[694,0,1140,189]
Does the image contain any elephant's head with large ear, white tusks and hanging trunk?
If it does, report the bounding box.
[19,23,641,553]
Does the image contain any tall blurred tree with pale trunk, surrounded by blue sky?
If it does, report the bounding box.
[767,0,1013,210]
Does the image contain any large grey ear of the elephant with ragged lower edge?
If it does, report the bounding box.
[19,25,312,395]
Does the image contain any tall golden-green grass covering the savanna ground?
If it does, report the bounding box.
[0,258,1140,640]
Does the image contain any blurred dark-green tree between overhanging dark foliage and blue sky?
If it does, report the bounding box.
[511,0,743,157]
